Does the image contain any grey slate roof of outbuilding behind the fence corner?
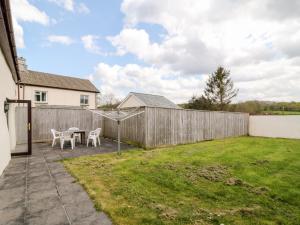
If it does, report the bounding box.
[130,92,180,109]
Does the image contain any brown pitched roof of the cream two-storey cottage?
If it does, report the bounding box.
[20,70,99,93]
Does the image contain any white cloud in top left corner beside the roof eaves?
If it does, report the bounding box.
[11,0,50,48]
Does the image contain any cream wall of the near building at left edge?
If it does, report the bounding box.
[0,50,17,175]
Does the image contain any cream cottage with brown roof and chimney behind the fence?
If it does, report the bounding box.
[18,57,99,109]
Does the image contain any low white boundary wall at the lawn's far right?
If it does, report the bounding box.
[249,115,300,139]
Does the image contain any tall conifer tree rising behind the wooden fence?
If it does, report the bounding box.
[204,67,238,110]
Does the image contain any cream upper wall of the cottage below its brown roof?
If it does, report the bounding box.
[20,86,96,109]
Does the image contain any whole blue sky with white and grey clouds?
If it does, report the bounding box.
[11,0,300,103]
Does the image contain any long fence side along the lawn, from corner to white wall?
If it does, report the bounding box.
[145,107,249,147]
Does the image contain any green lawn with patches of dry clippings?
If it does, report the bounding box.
[64,137,300,225]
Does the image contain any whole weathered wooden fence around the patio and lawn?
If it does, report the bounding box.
[16,107,249,148]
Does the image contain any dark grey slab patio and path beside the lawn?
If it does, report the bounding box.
[0,138,131,225]
